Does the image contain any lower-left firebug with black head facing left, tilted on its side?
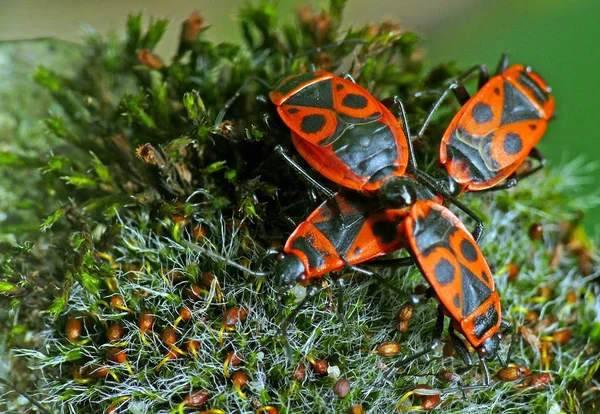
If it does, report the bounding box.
[274,177,441,290]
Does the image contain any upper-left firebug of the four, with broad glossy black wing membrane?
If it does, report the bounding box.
[270,72,483,239]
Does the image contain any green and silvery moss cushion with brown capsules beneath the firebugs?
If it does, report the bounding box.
[0,2,600,413]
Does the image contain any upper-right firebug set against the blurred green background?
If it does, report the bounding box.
[419,55,555,192]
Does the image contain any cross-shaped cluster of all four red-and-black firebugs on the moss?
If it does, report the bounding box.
[189,53,554,392]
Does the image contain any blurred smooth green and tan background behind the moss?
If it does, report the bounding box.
[0,0,600,235]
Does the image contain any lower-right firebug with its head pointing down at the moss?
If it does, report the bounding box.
[400,200,504,376]
